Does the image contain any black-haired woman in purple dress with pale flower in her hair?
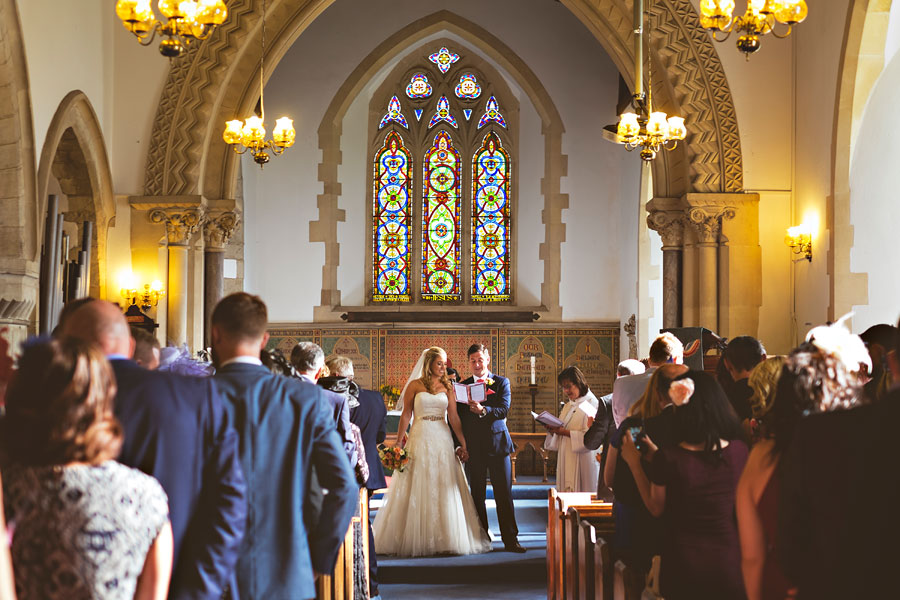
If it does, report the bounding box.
[622,371,748,600]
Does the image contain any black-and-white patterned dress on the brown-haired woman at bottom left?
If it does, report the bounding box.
[3,461,169,600]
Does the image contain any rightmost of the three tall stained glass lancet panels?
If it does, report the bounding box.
[472,132,510,301]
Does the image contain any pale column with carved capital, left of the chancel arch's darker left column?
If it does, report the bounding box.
[150,208,203,346]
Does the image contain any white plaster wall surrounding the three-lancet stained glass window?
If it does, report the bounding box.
[244,0,639,321]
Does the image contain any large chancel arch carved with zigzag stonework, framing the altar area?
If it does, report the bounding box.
[145,0,743,204]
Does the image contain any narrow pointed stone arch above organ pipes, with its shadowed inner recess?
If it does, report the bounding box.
[37,90,116,298]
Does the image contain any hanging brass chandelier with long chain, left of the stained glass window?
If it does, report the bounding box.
[222,0,297,168]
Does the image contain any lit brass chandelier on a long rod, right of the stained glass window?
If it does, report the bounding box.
[616,0,687,161]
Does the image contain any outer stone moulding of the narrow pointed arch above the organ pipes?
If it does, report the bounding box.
[37,90,116,298]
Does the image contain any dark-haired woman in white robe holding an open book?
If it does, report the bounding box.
[544,366,601,493]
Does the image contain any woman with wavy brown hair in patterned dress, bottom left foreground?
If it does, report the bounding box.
[0,339,172,600]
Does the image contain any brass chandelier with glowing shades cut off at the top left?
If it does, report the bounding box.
[116,0,228,58]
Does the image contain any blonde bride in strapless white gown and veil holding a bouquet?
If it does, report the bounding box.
[372,347,491,556]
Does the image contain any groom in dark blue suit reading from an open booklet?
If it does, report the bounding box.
[459,344,525,552]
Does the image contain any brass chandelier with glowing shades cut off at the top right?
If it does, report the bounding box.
[700,0,808,60]
